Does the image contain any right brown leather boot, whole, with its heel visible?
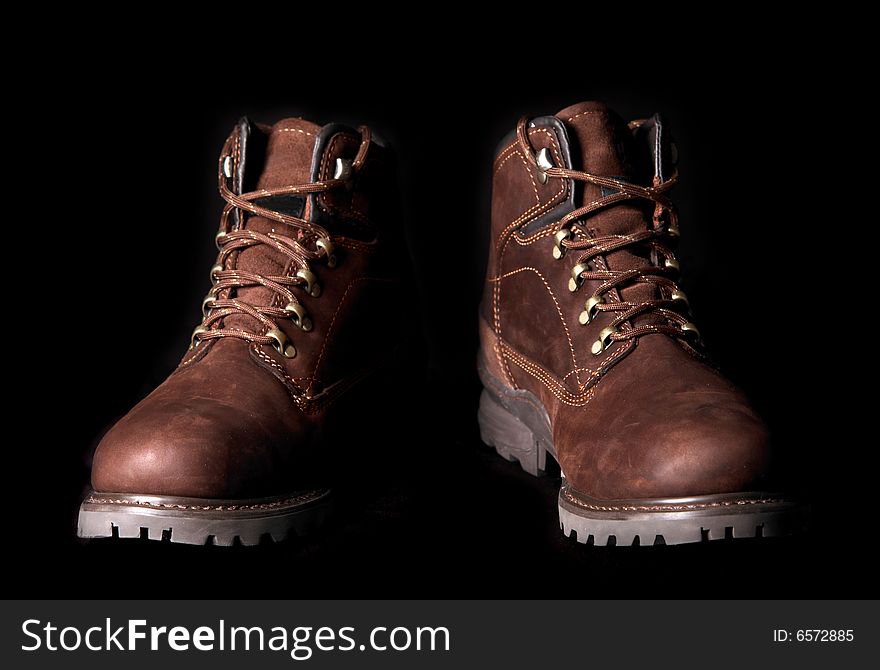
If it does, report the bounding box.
[479,102,801,544]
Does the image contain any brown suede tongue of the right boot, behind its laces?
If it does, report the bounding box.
[556,102,656,316]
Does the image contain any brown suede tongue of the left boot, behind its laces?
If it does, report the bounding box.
[224,119,321,331]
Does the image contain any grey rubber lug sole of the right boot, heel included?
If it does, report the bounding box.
[478,388,808,546]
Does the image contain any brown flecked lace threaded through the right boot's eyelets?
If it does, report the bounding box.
[517,117,700,355]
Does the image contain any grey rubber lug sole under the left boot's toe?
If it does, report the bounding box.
[77,489,330,547]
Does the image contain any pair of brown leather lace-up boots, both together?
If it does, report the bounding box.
[79,103,800,545]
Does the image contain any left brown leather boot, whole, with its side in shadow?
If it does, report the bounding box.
[79,119,405,545]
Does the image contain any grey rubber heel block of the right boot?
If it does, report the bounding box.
[477,390,547,476]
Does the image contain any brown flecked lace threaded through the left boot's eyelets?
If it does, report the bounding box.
[191,126,370,358]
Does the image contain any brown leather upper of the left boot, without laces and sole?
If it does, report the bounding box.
[92,119,403,498]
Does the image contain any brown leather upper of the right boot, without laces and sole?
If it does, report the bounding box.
[480,103,770,499]
